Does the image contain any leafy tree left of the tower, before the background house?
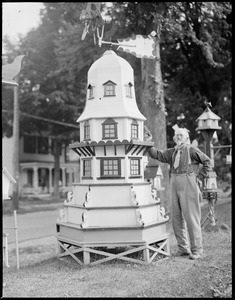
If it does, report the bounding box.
[2,3,84,202]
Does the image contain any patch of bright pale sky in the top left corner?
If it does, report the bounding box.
[2,2,44,42]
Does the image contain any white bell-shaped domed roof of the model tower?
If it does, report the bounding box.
[77,50,146,122]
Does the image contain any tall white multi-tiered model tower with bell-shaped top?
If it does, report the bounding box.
[57,50,170,264]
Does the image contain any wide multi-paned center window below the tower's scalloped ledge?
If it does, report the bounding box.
[100,158,121,177]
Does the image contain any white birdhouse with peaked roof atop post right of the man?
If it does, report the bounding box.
[196,106,221,131]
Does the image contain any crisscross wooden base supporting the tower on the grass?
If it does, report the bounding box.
[56,234,170,265]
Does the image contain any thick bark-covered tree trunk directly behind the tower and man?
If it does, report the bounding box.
[140,38,170,211]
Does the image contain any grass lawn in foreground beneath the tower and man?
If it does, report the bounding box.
[2,200,232,298]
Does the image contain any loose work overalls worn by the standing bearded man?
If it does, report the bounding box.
[171,146,203,253]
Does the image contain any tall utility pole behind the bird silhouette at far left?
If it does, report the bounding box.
[12,76,20,210]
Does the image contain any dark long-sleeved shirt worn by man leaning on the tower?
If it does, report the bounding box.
[148,144,212,181]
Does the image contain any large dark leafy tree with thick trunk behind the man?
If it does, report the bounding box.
[104,2,231,206]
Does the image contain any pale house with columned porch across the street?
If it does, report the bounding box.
[2,134,80,197]
